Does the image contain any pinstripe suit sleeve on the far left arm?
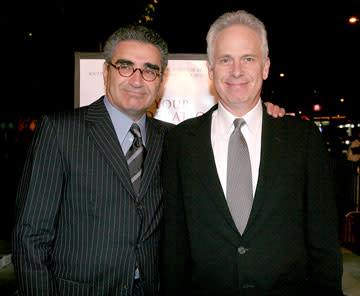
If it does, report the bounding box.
[12,117,64,296]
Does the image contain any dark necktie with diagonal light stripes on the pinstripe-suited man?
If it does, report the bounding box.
[126,123,145,194]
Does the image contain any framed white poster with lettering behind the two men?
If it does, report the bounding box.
[74,52,217,124]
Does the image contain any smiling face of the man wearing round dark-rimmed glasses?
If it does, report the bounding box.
[103,40,163,121]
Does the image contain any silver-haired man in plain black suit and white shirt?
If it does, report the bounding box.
[160,11,342,296]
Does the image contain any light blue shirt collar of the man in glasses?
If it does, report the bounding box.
[104,95,146,143]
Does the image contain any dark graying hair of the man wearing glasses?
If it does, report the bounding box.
[103,25,168,72]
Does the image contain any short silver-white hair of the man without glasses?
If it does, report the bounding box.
[206,10,269,65]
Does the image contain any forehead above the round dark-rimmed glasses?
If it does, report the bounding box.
[112,40,161,67]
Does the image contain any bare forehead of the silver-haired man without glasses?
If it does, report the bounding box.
[214,25,261,55]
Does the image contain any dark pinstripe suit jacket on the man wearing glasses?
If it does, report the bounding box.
[13,98,171,296]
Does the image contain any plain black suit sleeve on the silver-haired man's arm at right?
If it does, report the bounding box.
[305,121,342,295]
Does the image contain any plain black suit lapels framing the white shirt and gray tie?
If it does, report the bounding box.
[188,106,287,235]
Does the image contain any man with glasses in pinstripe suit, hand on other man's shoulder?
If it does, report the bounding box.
[13,26,284,296]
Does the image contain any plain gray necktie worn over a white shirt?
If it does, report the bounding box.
[226,118,253,234]
